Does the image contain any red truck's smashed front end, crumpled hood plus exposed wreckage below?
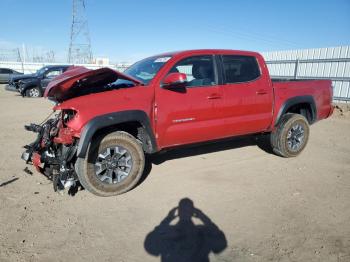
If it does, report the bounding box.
[22,66,142,194]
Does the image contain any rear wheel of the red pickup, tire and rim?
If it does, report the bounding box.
[270,114,310,157]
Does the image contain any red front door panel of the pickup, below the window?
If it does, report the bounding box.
[156,86,223,147]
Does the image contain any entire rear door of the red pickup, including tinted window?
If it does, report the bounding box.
[221,55,273,135]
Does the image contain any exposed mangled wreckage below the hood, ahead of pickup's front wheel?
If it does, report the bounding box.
[22,110,78,191]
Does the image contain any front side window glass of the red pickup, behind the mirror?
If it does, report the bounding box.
[169,55,217,87]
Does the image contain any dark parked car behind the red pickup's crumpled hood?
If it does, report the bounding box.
[7,65,70,97]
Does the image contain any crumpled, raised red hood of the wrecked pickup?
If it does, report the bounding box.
[44,66,142,102]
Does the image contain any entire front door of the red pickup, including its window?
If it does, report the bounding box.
[155,55,223,148]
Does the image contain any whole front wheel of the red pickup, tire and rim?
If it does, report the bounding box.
[76,131,145,196]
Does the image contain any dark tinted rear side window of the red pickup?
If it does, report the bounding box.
[222,55,260,83]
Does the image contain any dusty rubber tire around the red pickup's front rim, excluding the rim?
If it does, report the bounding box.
[76,131,145,197]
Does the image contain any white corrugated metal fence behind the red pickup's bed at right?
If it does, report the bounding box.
[263,46,350,102]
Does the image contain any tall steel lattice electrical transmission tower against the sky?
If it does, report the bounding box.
[68,0,92,64]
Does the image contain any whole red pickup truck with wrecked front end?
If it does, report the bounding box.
[22,50,333,196]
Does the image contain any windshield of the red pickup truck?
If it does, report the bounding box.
[124,56,171,84]
